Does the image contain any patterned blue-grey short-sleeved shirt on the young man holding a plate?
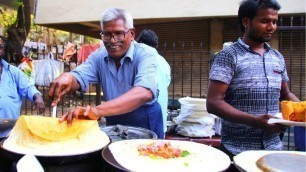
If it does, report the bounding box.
[209,38,288,154]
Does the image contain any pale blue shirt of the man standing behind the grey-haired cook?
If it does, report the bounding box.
[156,51,171,132]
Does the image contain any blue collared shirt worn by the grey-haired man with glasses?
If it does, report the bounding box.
[71,41,157,103]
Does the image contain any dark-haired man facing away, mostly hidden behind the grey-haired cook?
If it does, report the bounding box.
[136,29,171,132]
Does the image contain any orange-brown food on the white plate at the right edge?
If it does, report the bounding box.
[281,101,306,122]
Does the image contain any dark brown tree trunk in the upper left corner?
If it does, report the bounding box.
[5,0,31,64]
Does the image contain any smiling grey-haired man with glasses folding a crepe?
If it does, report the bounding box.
[49,8,164,138]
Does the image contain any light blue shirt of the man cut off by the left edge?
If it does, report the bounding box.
[0,59,40,119]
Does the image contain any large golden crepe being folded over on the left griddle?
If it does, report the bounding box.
[3,115,110,156]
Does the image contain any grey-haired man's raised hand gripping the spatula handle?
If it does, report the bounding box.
[48,72,79,106]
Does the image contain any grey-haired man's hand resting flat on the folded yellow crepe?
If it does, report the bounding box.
[60,106,100,126]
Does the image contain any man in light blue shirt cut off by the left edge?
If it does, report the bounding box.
[0,35,45,171]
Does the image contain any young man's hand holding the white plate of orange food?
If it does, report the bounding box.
[256,114,287,133]
